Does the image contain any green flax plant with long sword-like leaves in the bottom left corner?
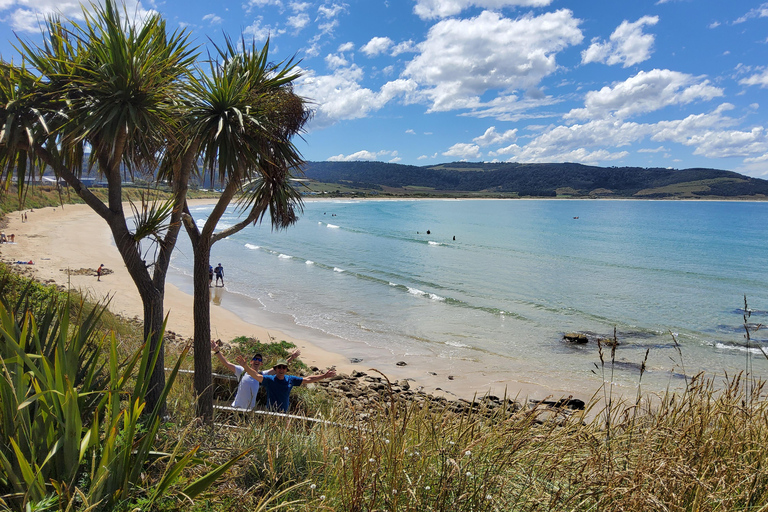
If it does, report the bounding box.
[0,290,242,510]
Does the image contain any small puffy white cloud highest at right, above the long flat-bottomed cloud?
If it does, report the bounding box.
[581,16,659,68]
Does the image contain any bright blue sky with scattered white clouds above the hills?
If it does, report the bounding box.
[0,0,768,179]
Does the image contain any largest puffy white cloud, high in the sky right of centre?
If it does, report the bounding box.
[404,9,583,111]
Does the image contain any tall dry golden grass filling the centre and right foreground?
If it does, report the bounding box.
[160,368,768,511]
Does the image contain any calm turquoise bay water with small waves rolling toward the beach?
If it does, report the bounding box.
[173,200,768,396]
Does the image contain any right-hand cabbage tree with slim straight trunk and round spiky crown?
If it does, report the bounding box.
[178,39,310,418]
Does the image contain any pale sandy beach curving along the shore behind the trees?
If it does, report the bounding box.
[0,200,590,400]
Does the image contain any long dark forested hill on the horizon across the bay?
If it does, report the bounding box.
[305,162,768,199]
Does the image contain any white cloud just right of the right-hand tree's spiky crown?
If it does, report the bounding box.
[296,64,416,127]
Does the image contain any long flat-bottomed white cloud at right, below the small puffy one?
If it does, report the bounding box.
[564,69,723,120]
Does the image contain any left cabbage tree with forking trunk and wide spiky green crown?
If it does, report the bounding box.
[0,0,196,414]
